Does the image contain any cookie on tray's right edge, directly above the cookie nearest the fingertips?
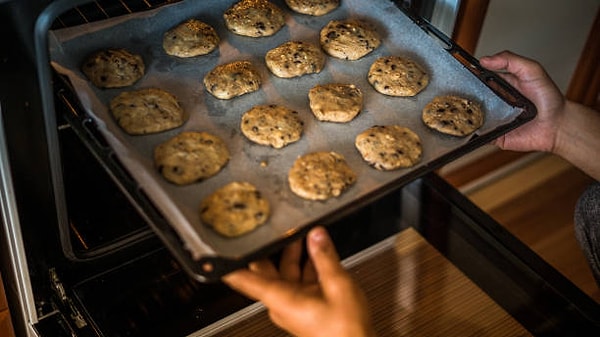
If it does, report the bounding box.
[319,19,381,61]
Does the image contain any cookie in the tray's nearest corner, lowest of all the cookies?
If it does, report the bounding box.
[200,181,271,237]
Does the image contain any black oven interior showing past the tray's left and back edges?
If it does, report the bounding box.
[52,0,175,260]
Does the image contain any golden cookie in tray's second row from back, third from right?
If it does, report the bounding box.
[204,61,262,99]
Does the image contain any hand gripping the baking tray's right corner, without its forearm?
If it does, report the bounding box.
[479,51,566,152]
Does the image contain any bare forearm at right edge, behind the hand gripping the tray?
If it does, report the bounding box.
[552,101,600,180]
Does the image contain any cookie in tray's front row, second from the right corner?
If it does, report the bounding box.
[354,125,423,171]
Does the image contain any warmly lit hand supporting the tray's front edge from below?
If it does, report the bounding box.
[223,227,374,337]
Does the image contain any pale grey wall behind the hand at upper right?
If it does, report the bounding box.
[475,0,600,93]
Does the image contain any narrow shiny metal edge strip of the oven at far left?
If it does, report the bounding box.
[0,102,38,336]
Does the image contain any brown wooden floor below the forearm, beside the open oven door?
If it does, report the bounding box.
[442,147,600,303]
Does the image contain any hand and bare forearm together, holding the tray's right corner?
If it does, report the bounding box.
[480,51,600,180]
